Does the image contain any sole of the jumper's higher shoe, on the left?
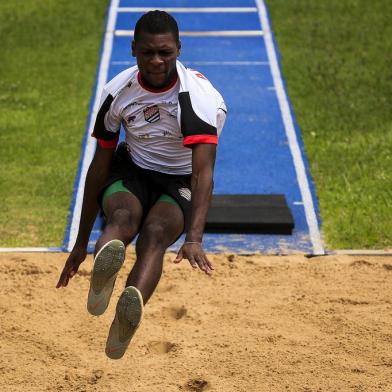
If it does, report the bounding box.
[87,240,125,316]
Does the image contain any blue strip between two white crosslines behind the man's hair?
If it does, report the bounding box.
[116,12,260,31]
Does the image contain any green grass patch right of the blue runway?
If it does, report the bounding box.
[267,0,392,249]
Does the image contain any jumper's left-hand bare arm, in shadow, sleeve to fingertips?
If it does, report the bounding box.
[56,144,114,288]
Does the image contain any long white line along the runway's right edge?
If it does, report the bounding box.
[256,0,325,255]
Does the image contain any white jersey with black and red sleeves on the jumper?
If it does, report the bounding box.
[93,62,226,175]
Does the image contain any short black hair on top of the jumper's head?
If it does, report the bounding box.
[133,10,180,42]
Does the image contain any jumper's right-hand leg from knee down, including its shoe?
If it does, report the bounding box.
[105,201,184,359]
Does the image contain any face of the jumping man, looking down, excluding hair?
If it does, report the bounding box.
[132,32,181,88]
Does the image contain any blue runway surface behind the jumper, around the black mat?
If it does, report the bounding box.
[66,0,324,253]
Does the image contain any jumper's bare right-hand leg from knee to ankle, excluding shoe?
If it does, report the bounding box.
[126,201,184,304]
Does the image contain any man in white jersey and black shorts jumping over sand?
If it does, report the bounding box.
[57,11,226,359]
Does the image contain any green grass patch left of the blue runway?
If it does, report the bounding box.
[0,0,106,246]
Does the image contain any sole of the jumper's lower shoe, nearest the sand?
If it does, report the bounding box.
[105,286,144,359]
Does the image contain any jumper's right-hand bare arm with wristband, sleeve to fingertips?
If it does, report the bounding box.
[175,144,216,274]
